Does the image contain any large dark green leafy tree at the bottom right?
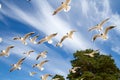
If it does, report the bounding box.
[67,49,120,80]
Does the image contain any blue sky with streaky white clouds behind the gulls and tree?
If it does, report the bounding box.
[0,0,120,80]
